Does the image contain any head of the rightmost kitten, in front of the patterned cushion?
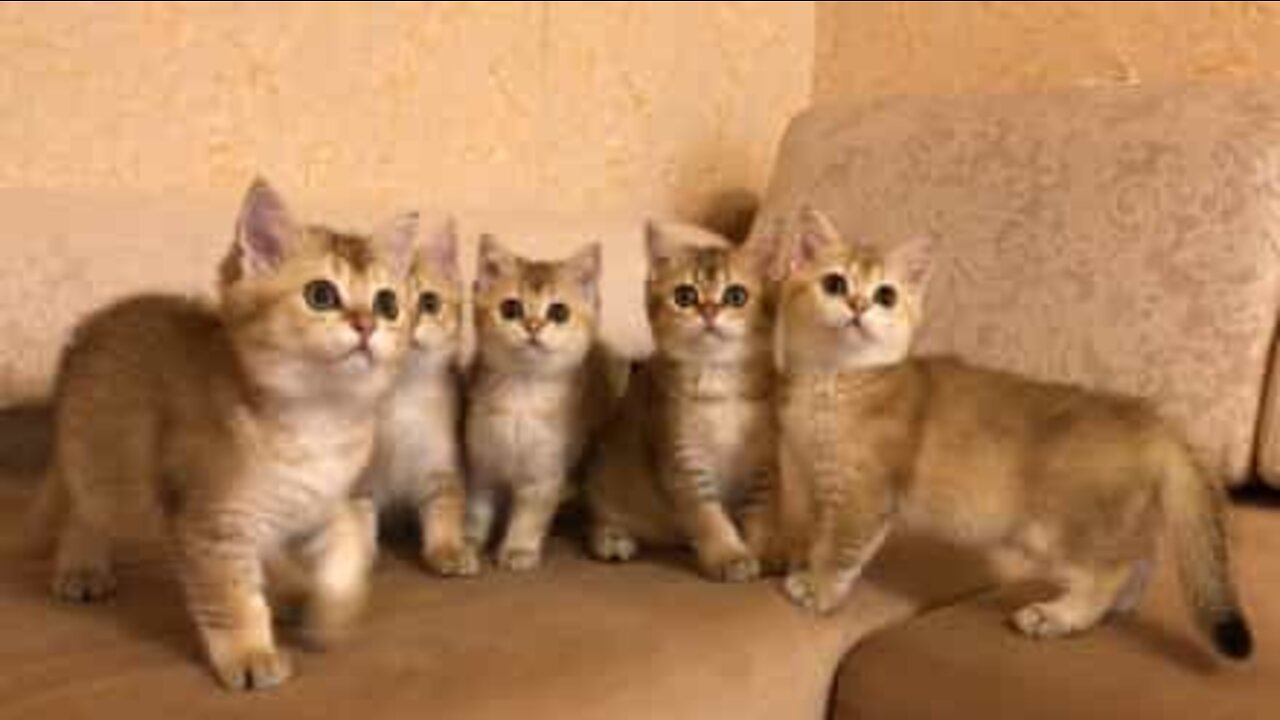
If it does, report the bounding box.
[781,208,933,369]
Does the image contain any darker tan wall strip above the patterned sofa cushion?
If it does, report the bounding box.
[814,3,1280,100]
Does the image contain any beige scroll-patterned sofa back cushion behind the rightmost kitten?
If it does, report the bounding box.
[753,85,1280,483]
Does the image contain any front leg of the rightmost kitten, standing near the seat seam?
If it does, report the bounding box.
[783,486,891,614]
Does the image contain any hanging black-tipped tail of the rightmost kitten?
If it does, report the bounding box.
[1161,442,1253,660]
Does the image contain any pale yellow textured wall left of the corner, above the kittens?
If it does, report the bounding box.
[0,3,814,214]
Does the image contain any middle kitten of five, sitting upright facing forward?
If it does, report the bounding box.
[466,236,612,570]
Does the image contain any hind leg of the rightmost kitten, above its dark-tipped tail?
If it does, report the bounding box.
[1010,565,1132,638]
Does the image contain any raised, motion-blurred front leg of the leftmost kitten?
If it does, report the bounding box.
[301,498,376,647]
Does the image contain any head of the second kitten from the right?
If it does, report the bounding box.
[645,222,773,363]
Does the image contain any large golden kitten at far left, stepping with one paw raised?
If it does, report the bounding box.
[27,181,417,689]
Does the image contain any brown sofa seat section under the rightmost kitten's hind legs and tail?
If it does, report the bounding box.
[833,497,1280,720]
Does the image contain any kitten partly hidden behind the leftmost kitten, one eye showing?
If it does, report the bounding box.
[361,220,480,575]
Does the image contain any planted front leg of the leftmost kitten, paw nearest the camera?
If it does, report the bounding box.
[175,516,292,691]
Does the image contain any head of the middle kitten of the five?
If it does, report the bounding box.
[475,234,600,374]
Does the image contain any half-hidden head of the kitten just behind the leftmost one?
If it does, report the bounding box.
[406,218,463,361]
